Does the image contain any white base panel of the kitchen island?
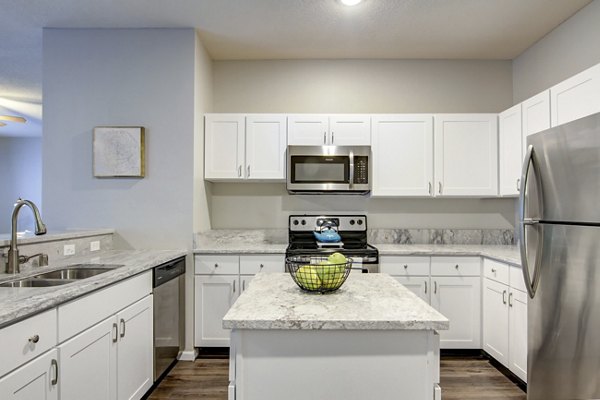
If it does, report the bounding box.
[229,330,441,400]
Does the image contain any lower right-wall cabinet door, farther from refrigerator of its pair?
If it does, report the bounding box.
[483,278,509,365]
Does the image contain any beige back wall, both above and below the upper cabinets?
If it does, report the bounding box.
[211,60,515,228]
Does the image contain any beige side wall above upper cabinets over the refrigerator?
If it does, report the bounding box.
[513,0,600,104]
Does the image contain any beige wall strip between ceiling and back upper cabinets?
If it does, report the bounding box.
[214,60,512,113]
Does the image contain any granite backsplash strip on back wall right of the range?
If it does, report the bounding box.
[368,229,516,245]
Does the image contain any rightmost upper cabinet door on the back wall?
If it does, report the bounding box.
[434,114,498,196]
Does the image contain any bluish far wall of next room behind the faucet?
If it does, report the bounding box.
[0,137,44,233]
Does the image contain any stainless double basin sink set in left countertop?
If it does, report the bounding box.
[0,264,123,287]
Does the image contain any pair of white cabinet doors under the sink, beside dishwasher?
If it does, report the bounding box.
[58,295,153,400]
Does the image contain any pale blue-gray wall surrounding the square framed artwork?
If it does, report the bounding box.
[42,29,196,249]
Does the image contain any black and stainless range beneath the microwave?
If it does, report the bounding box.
[285,215,379,273]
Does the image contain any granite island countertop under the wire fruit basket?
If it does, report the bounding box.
[223,272,449,330]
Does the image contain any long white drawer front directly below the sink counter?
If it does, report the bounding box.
[58,271,152,342]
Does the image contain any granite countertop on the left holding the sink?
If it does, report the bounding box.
[0,250,185,328]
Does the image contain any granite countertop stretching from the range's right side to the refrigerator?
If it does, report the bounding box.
[374,244,521,266]
